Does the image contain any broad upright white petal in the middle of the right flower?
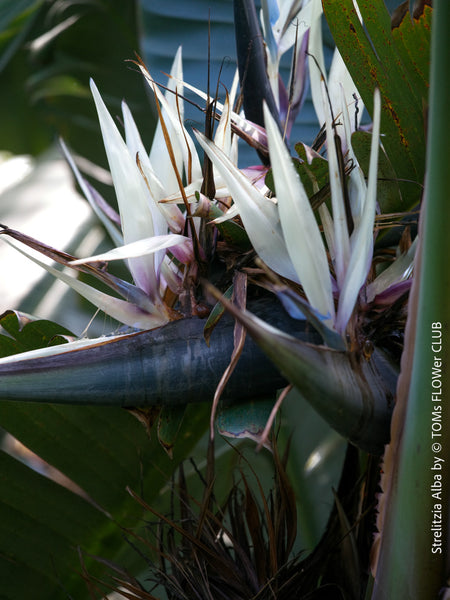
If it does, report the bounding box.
[264,105,334,328]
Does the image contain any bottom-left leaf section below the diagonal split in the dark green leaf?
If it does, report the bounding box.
[0,452,105,599]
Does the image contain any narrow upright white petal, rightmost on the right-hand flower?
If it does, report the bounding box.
[336,89,381,332]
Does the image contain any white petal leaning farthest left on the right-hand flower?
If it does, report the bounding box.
[195,131,298,281]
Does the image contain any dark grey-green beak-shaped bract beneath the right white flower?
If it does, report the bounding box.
[205,286,397,454]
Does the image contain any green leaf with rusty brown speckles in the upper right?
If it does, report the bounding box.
[323,0,432,211]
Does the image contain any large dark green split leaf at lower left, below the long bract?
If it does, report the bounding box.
[0,402,208,600]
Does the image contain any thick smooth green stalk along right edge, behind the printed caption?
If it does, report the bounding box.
[372,0,450,600]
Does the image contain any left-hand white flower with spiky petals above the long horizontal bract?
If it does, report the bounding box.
[2,52,201,329]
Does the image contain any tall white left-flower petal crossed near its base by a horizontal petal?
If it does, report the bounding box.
[91,80,158,297]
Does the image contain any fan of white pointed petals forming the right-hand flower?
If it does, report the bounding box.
[197,85,380,344]
